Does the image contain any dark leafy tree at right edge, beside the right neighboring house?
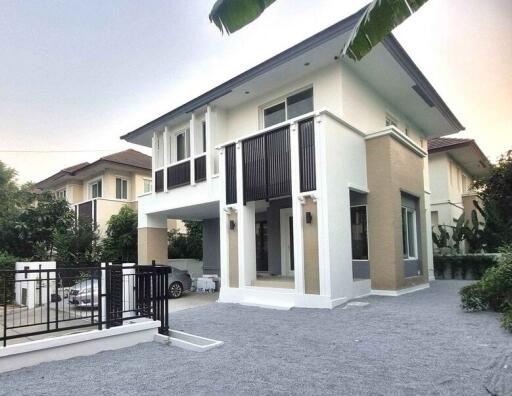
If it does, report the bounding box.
[474,151,512,251]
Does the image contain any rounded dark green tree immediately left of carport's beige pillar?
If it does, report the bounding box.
[103,206,137,262]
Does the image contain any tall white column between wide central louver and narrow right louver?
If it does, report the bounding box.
[288,123,304,294]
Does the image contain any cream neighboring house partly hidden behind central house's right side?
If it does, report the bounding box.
[428,137,490,237]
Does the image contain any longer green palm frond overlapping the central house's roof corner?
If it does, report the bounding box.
[342,0,428,61]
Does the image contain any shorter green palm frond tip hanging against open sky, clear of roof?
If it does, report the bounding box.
[210,0,275,34]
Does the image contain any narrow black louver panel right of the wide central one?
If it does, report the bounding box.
[299,118,316,192]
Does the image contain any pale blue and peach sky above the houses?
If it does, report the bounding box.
[0,0,512,182]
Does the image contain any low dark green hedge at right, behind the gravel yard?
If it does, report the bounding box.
[434,254,497,280]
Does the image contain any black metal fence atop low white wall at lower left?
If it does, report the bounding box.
[0,263,170,346]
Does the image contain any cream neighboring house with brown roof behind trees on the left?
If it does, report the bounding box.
[36,149,152,234]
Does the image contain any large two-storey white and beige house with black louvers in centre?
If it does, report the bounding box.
[122,8,463,308]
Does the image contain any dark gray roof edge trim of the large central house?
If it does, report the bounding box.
[121,7,464,140]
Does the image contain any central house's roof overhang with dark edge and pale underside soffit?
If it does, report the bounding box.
[121,9,464,147]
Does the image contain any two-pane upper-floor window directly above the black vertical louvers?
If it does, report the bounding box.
[263,88,313,128]
